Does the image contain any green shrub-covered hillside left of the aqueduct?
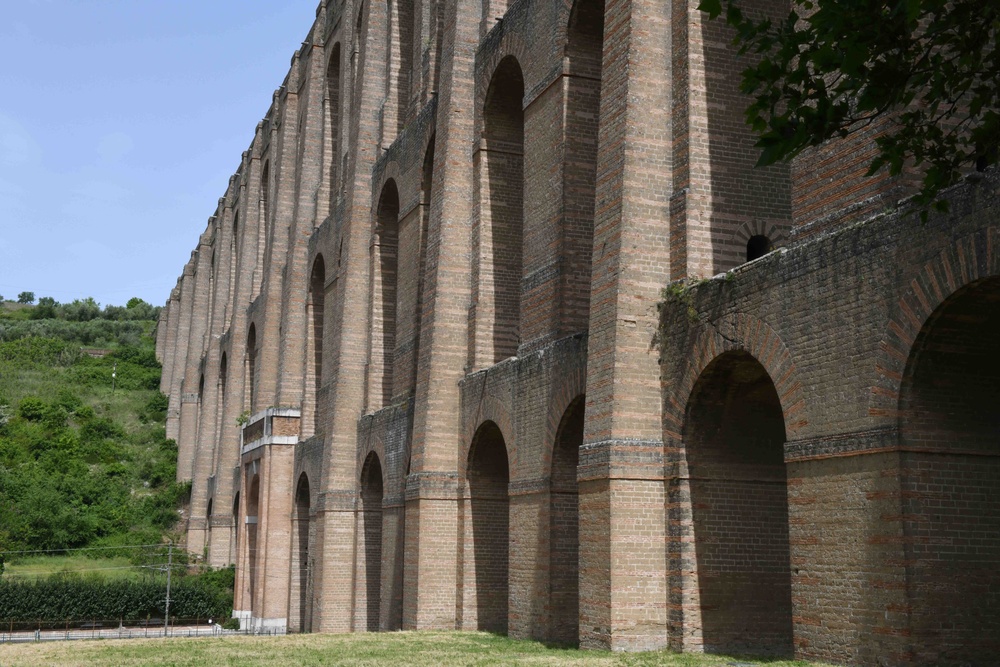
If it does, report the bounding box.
[0,298,187,562]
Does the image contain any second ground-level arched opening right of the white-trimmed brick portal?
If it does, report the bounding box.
[358,452,382,632]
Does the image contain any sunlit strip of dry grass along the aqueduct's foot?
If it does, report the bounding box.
[0,632,818,667]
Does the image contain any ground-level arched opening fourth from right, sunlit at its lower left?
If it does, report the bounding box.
[463,421,510,634]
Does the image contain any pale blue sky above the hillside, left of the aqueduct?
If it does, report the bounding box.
[0,0,319,305]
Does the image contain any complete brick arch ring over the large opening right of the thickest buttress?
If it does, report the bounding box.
[664,314,809,448]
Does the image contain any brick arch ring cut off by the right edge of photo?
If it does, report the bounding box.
[868,225,1000,426]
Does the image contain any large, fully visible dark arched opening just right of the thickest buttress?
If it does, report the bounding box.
[683,351,793,656]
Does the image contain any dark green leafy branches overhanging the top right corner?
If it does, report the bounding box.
[700,0,1000,218]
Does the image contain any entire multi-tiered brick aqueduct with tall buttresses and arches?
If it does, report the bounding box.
[157,0,1000,665]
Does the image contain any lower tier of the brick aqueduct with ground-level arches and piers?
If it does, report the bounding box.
[225,177,1000,665]
